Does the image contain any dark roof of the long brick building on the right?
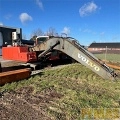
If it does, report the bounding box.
[89,42,120,48]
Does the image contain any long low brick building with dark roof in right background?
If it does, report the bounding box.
[88,42,120,54]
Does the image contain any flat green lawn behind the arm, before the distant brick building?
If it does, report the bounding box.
[94,54,120,63]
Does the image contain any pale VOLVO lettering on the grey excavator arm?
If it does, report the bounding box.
[78,53,100,71]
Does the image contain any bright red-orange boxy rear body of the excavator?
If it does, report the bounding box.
[2,46,37,62]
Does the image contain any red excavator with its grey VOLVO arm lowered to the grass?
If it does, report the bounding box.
[2,37,117,84]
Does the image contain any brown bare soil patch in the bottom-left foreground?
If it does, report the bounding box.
[0,87,60,120]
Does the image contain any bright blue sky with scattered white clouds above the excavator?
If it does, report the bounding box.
[0,0,120,45]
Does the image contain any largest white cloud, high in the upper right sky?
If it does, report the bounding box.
[79,2,98,17]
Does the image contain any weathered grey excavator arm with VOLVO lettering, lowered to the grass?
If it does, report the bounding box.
[33,37,117,80]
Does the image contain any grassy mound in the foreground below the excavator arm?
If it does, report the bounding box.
[0,63,120,120]
